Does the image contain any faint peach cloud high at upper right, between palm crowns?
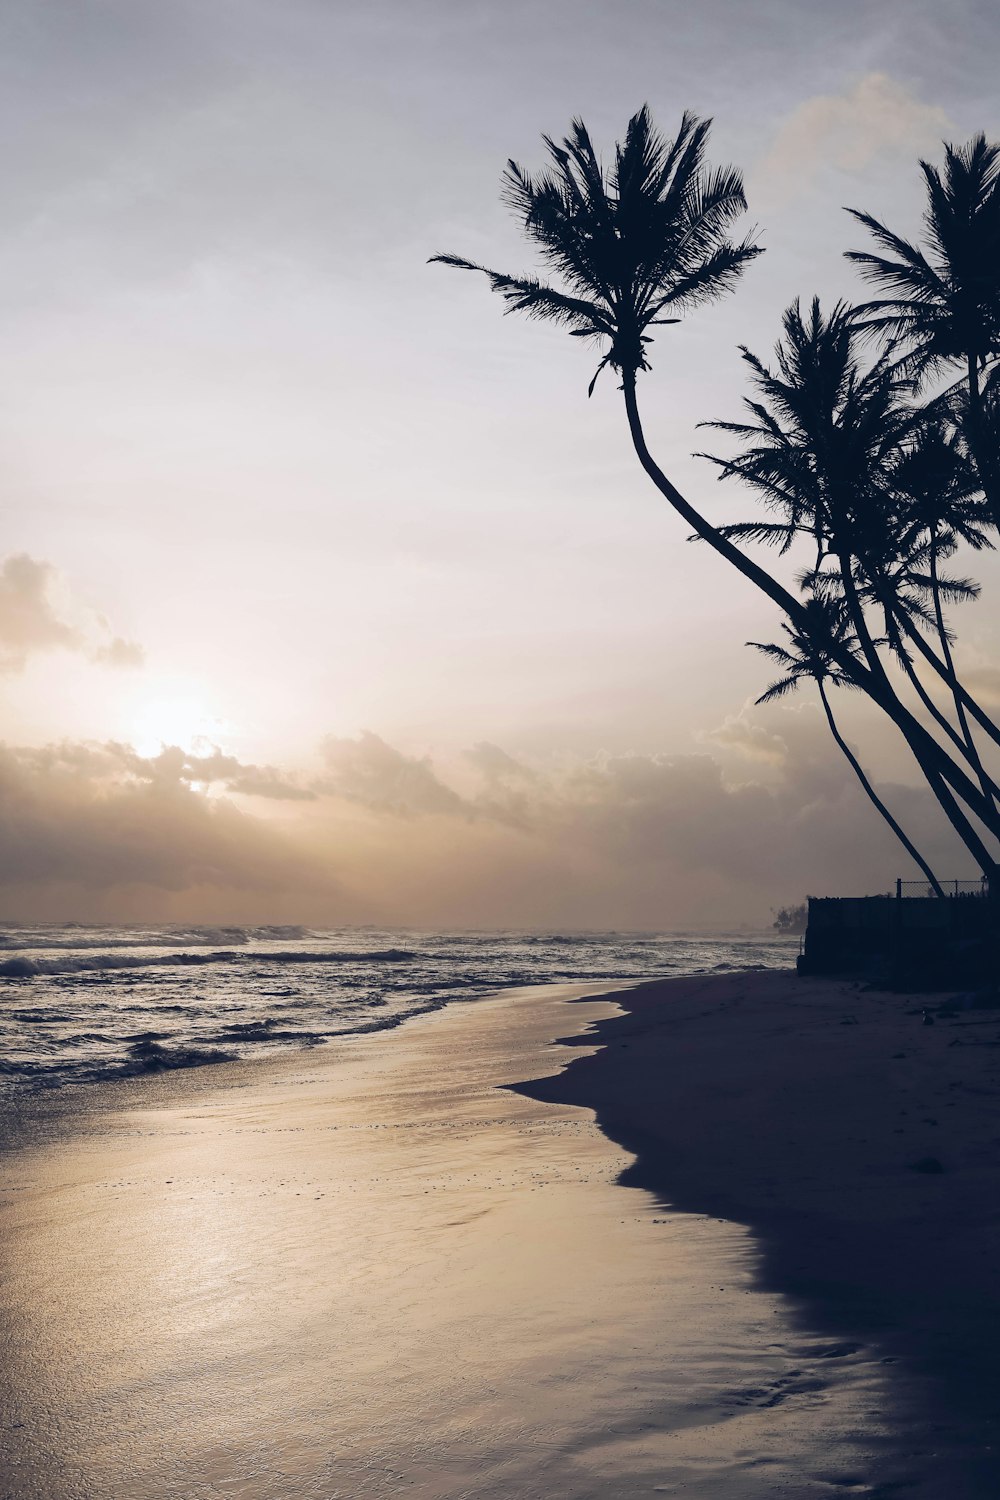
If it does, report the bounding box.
[754,72,952,198]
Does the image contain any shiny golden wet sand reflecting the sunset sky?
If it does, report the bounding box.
[1,987,885,1500]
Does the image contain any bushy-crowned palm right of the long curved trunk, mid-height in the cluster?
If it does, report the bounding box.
[702,300,1000,870]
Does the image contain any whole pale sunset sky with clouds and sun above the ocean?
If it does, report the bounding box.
[0,0,1000,929]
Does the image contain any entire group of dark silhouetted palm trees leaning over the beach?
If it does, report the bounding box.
[433,107,1000,894]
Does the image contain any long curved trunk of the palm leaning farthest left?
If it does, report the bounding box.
[622,369,1000,878]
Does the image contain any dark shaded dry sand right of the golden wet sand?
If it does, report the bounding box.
[520,972,1000,1496]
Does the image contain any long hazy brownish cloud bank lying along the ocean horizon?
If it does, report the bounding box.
[0,710,961,929]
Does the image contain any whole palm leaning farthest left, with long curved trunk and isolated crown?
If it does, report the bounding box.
[432,107,1000,870]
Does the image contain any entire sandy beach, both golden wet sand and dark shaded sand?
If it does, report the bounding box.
[0,975,1000,1500]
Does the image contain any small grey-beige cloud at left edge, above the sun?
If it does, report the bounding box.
[0,552,142,672]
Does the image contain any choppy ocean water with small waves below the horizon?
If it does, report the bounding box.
[0,923,798,1098]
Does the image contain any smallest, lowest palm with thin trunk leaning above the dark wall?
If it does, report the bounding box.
[747,596,945,896]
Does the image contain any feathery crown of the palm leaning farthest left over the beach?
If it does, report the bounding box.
[432,105,762,393]
